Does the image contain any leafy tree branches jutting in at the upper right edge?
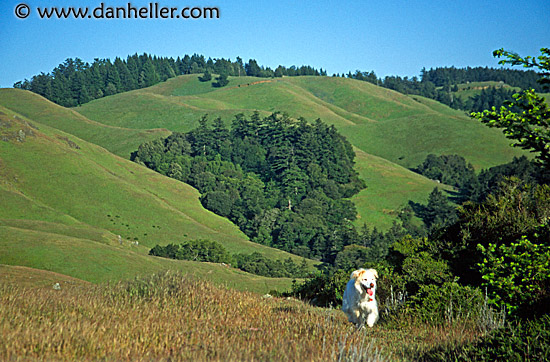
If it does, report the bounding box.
[472,48,550,170]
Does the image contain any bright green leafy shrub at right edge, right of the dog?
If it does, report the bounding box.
[478,232,550,313]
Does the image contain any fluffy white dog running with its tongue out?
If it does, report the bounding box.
[342,269,378,328]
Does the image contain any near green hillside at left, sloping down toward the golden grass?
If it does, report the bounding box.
[0,103,312,292]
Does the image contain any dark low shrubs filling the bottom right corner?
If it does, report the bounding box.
[422,315,550,361]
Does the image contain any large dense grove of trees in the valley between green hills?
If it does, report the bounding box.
[132,113,365,262]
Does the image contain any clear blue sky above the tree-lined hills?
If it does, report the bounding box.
[0,0,550,87]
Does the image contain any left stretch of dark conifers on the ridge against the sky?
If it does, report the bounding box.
[14,53,326,107]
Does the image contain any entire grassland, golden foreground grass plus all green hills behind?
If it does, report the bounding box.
[0,75,532,361]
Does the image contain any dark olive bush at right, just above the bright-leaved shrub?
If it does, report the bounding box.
[440,179,550,285]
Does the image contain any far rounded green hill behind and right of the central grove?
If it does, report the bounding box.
[74,75,520,229]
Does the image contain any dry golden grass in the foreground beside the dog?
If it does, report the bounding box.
[0,273,484,361]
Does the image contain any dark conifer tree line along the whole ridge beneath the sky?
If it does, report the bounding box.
[14,49,542,111]
